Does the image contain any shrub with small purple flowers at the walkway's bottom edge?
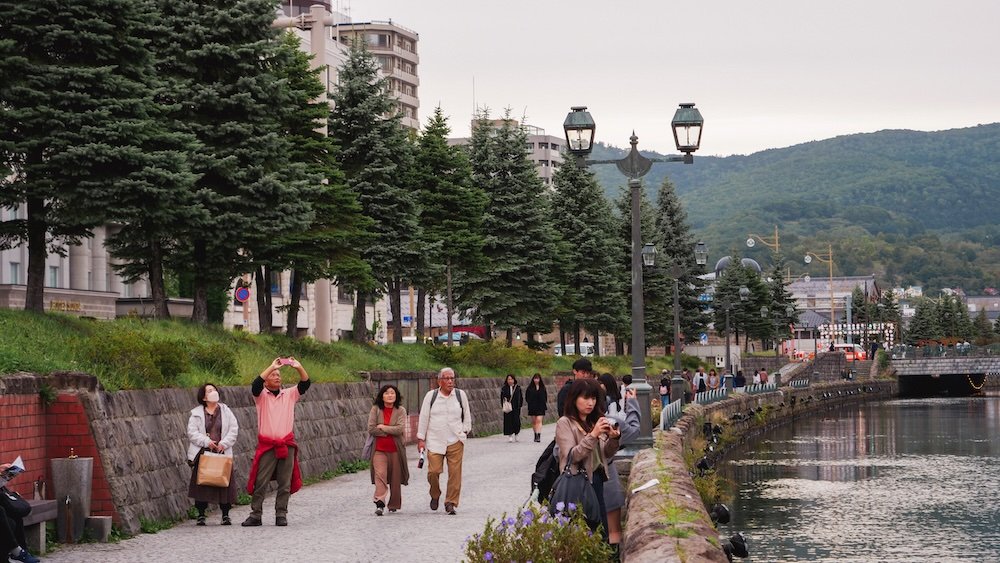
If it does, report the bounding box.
[465,505,611,563]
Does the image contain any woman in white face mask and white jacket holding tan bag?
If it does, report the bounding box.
[188,383,240,526]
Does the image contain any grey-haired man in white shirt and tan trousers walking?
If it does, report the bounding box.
[417,367,472,515]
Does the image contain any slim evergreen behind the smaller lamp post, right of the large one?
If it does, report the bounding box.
[656,178,708,350]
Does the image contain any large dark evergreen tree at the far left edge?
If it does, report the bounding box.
[0,0,193,312]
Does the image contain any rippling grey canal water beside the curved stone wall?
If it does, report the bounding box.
[719,392,1000,563]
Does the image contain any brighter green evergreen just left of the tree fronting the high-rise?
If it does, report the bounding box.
[266,33,371,336]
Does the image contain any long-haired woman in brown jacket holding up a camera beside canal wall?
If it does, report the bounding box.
[556,379,621,541]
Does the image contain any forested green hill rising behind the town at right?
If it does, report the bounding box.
[592,123,1000,294]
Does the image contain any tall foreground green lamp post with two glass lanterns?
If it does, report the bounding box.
[563,103,705,448]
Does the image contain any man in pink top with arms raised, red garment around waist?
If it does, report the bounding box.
[242,358,310,526]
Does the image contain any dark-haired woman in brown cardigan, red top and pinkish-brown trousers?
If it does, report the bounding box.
[368,384,410,516]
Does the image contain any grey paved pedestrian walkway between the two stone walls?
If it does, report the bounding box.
[43,424,555,563]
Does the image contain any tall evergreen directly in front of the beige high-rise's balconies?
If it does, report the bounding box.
[330,41,422,343]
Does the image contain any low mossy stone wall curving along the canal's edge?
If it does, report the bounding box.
[622,380,898,563]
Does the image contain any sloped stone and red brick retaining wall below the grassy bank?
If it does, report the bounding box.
[0,373,561,533]
